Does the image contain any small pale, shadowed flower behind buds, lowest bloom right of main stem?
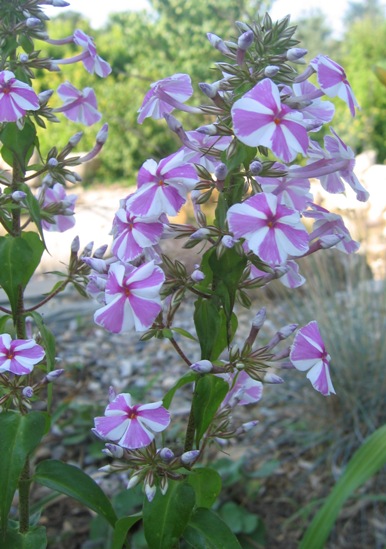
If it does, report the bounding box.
[219,370,263,407]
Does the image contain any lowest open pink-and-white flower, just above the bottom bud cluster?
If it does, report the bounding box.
[94,393,170,450]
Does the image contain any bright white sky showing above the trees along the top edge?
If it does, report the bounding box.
[45,0,349,36]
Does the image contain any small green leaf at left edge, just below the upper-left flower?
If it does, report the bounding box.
[0,119,36,173]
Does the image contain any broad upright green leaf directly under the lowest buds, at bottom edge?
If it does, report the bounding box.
[143,481,194,549]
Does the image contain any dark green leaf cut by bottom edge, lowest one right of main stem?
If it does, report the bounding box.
[189,508,242,549]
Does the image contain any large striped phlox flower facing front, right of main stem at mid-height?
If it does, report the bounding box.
[227,193,308,266]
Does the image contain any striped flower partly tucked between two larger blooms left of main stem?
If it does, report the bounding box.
[111,208,163,263]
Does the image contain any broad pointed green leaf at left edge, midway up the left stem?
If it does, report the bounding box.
[0,232,44,315]
